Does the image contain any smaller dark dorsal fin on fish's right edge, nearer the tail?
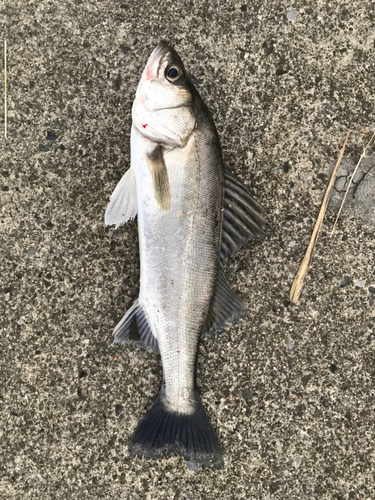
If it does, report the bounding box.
[201,271,245,337]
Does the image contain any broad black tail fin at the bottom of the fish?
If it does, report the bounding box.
[129,388,223,468]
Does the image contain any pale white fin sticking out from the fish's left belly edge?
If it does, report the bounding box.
[105,168,138,228]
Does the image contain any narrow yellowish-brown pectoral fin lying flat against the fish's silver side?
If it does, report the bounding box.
[146,146,171,212]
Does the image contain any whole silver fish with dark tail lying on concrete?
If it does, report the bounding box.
[105,40,267,468]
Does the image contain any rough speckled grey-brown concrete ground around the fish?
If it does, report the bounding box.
[0,0,375,500]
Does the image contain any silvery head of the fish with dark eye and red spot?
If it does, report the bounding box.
[132,41,196,147]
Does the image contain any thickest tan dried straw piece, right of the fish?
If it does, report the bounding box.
[290,130,351,303]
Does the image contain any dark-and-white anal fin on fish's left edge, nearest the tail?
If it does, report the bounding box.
[113,299,159,354]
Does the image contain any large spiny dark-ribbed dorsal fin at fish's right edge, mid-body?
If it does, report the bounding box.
[220,170,267,263]
